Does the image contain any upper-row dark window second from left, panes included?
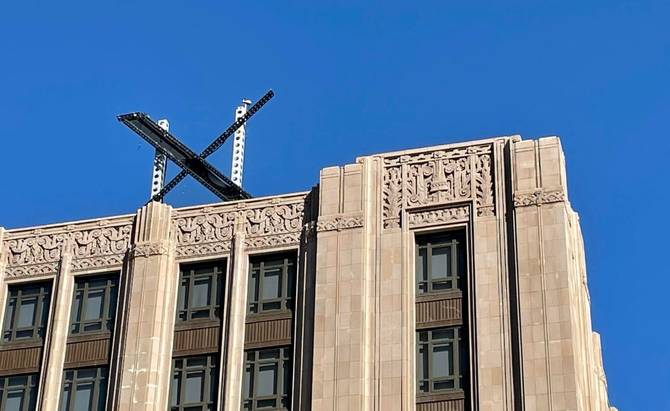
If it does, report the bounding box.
[70,275,118,335]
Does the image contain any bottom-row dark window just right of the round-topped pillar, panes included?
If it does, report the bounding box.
[170,355,219,411]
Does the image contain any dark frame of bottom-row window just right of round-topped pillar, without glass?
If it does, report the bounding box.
[168,354,219,411]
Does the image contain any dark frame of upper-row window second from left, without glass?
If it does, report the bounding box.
[68,273,119,337]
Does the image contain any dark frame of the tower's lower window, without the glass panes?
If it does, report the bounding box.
[415,326,467,397]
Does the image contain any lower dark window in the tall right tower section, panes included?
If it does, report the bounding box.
[416,327,465,394]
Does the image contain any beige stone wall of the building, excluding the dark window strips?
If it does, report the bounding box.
[0,136,609,411]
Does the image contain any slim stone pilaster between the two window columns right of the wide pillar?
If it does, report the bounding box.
[222,230,249,411]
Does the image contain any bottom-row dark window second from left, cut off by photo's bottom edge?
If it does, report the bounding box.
[61,367,107,411]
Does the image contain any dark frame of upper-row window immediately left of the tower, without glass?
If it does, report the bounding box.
[247,252,298,316]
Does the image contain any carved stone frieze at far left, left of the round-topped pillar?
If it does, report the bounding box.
[6,216,132,277]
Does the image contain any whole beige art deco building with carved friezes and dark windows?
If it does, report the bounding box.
[0,136,610,411]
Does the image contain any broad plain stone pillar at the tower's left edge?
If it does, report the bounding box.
[311,164,374,411]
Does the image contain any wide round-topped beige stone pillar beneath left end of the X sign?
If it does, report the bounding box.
[115,202,179,411]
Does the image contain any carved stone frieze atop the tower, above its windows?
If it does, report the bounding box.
[382,144,495,228]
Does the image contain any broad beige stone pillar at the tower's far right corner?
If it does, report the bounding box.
[513,137,598,411]
